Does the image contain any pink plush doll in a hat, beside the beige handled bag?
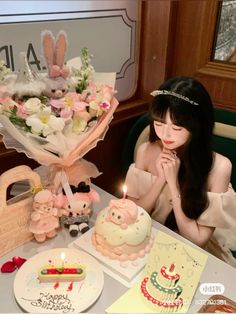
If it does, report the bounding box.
[29,190,59,242]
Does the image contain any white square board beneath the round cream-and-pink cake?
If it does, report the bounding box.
[69,227,157,288]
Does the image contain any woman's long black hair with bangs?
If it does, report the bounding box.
[149,76,214,228]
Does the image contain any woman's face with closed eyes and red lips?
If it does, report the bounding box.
[153,110,190,150]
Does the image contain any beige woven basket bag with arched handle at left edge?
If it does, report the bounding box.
[0,166,41,256]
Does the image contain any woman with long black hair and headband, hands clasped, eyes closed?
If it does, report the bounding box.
[126,77,236,266]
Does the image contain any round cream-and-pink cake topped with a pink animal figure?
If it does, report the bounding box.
[92,199,153,261]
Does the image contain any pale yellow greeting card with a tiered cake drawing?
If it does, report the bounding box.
[106,231,207,313]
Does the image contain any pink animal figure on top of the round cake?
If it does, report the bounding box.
[106,199,138,229]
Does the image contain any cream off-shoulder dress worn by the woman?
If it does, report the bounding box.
[126,164,236,267]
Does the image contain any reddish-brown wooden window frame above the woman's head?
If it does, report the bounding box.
[168,0,236,111]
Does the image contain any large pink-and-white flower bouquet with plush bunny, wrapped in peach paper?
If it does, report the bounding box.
[0,31,118,196]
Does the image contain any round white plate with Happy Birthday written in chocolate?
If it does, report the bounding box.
[14,248,104,313]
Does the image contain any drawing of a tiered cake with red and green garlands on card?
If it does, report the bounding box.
[141,264,183,311]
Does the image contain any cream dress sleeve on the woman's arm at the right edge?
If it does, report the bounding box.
[197,185,236,228]
